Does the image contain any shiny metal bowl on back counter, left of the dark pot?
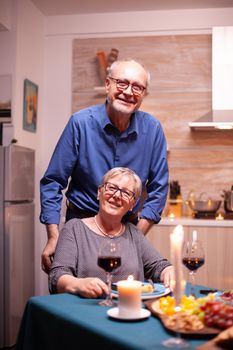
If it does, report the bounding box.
[188,192,222,213]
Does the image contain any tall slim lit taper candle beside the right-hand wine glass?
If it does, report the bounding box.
[170,225,184,305]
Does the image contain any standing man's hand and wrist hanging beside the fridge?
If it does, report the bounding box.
[41,224,59,273]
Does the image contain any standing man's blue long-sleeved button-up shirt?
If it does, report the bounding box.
[40,104,168,224]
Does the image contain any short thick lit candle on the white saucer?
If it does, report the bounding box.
[117,276,142,316]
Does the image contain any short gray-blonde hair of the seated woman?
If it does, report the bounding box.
[101,167,142,200]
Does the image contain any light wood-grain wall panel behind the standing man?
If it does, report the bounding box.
[72,35,233,206]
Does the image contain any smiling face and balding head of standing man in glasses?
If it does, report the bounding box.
[105,62,147,115]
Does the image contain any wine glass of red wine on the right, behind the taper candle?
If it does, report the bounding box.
[182,240,205,297]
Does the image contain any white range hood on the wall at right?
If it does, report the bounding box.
[189,27,233,131]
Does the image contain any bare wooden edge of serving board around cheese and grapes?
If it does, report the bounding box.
[144,299,220,336]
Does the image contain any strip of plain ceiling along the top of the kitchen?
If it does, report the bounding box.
[31,0,233,16]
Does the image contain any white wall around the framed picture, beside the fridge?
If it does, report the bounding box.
[13,0,47,294]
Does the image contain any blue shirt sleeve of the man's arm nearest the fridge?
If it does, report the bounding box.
[40,116,79,224]
